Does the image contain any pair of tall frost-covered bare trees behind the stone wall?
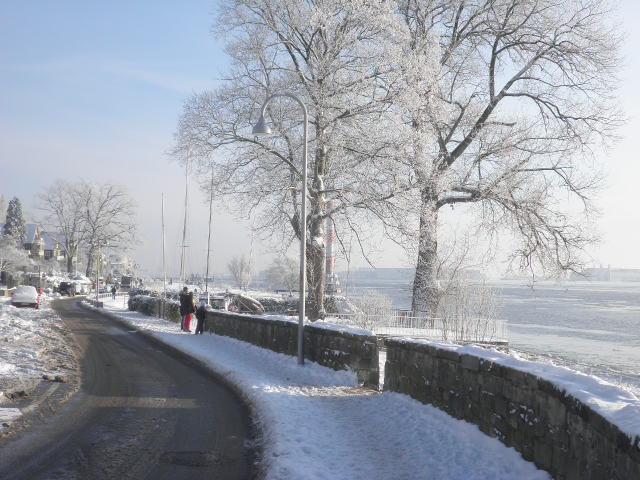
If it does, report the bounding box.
[174,0,621,319]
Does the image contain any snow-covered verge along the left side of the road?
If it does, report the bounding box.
[0,297,75,430]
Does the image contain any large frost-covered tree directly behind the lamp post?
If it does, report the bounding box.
[175,0,404,319]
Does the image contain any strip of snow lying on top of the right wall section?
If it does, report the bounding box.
[398,338,640,438]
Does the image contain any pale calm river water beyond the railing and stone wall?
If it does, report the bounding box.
[348,281,640,394]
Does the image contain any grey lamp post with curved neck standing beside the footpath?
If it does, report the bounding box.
[252,93,309,365]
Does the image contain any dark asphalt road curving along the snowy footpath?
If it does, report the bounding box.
[0,300,255,480]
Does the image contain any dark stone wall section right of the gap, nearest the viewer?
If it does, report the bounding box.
[384,339,640,480]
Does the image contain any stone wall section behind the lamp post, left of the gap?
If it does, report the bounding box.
[205,310,379,389]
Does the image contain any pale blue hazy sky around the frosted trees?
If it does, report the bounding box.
[0,0,640,271]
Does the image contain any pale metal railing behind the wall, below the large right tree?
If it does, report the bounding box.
[327,310,507,343]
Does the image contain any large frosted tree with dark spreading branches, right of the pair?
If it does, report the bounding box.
[385,0,620,314]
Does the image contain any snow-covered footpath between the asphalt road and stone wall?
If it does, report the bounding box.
[91,299,551,480]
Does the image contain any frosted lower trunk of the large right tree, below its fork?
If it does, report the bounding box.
[411,187,439,318]
